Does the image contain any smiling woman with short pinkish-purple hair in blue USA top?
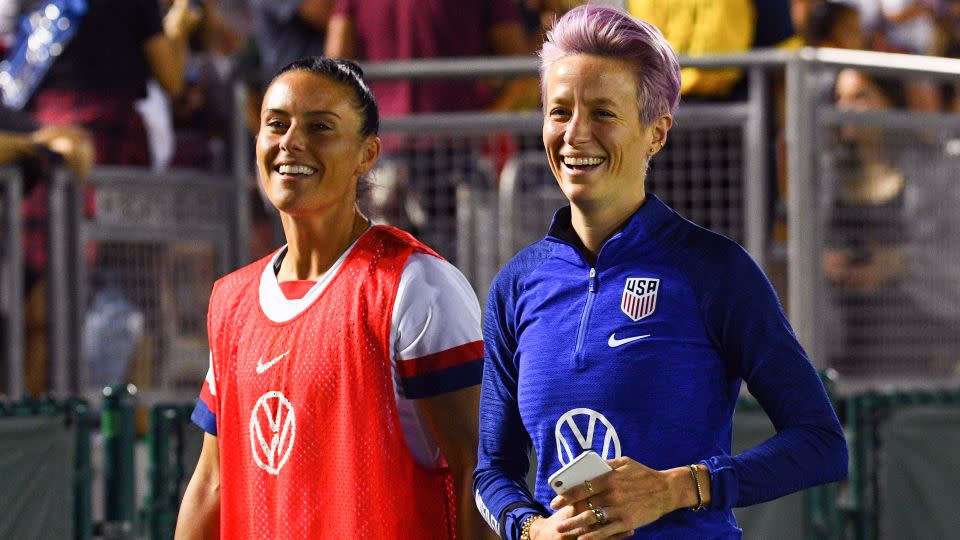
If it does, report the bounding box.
[474,6,847,540]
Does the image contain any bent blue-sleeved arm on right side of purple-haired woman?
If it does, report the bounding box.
[700,246,847,509]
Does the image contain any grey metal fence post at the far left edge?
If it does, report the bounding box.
[0,167,26,400]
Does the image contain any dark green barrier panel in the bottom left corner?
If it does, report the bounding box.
[0,397,93,540]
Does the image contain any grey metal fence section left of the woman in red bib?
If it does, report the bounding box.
[0,167,249,402]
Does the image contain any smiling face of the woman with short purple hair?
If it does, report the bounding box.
[543,54,672,213]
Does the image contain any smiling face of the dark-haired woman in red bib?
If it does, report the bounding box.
[257,71,380,216]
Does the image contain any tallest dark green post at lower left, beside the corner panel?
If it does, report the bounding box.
[100,384,137,539]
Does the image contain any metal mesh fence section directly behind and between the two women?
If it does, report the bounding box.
[366,63,773,300]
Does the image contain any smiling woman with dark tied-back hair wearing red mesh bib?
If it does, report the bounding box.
[177,58,496,540]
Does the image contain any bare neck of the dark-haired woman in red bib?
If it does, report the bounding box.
[277,201,369,281]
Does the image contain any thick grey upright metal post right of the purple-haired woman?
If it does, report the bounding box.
[787,49,826,368]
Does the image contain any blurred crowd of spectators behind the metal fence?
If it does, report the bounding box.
[0,0,960,408]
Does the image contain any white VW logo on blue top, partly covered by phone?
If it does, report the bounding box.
[554,408,620,465]
